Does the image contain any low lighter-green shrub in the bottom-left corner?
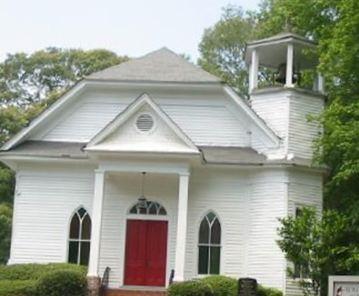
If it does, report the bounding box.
[0,280,36,296]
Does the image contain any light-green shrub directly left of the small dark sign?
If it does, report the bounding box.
[202,275,238,296]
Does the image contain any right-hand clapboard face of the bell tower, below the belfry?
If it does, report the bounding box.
[288,95,324,159]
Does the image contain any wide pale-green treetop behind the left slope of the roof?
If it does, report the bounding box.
[0,48,127,106]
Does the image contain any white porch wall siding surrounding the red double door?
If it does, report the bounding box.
[100,173,178,288]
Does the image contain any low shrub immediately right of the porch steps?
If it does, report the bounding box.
[167,280,214,296]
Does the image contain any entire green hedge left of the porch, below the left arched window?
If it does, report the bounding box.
[0,264,86,296]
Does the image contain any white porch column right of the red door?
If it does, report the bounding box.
[174,174,189,282]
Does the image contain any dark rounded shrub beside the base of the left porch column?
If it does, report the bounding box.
[35,270,87,296]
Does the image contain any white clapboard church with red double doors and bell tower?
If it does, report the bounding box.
[0,33,325,295]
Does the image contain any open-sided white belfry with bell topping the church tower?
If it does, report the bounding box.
[245,33,324,94]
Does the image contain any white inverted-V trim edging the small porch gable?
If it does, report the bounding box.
[84,93,200,153]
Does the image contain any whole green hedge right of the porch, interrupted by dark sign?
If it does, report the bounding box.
[167,275,283,296]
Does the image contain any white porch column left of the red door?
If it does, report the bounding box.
[87,170,105,277]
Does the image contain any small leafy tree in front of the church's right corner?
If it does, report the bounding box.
[278,209,359,296]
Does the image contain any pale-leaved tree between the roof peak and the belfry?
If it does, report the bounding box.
[198,6,255,96]
